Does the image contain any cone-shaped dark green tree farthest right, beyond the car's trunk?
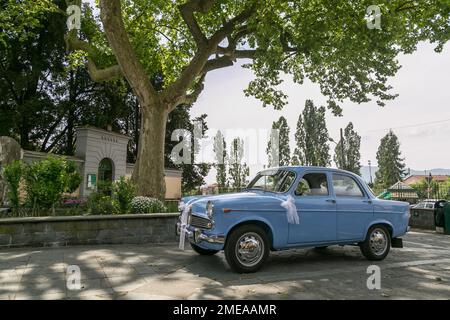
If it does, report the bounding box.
[375,130,405,189]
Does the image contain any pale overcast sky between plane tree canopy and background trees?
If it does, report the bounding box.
[188,44,450,182]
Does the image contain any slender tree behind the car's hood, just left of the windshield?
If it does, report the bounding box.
[228,138,250,189]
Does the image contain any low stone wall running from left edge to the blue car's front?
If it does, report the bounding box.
[0,213,178,248]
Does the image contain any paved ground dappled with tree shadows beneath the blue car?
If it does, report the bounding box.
[0,231,450,300]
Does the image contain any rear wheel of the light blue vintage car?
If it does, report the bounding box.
[359,226,391,261]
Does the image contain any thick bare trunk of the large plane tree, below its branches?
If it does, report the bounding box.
[133,105,168,200]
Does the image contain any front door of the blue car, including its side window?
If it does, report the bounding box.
[288,171,336,244]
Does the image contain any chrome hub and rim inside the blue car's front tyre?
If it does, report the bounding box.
[235,232,264,267]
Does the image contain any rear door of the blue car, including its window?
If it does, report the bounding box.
[332,173,373,240]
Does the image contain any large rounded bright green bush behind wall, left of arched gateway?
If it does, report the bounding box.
[23,156,81,212]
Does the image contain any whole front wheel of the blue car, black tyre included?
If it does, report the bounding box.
[225,225,270,273]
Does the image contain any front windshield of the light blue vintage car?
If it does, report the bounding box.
[247,170,295,192]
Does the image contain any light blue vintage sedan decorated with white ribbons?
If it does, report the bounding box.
[177,167,409,272]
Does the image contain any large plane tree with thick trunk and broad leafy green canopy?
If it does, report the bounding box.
[67,0,450,198]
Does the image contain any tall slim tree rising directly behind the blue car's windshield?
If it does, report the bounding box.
[266,117,291,167]
